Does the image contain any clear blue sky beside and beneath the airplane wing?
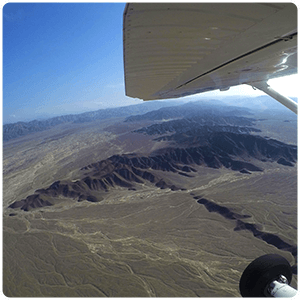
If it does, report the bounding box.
[2,2,299,123]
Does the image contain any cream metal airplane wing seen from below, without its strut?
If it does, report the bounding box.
[123,3,297,100]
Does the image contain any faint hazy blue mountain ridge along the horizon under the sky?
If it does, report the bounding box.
[3,100,250,142]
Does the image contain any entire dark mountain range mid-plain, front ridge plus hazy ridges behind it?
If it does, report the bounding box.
[9,103,297,211]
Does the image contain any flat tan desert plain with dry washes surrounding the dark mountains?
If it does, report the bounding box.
[3,102,297,297]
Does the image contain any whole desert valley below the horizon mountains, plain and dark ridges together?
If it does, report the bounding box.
[3,103,297,297]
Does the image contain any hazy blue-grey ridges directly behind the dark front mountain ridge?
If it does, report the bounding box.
[130,102,260,147]
